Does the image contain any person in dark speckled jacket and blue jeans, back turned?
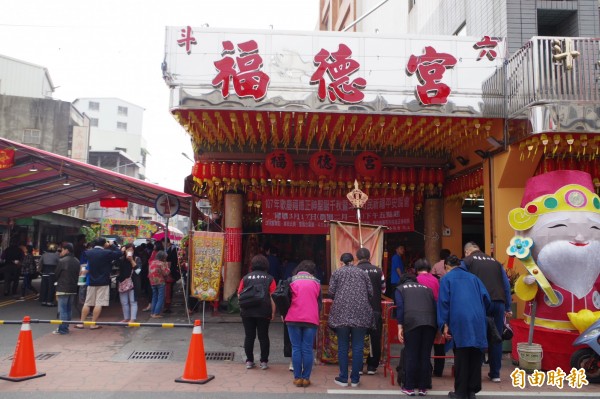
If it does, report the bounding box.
[328,253,374,387]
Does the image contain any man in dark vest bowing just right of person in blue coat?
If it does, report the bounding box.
[464,242,512,382]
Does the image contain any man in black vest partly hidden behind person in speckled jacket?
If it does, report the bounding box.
[356,248,385,375]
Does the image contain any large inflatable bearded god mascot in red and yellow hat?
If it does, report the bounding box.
[507,170,600,370]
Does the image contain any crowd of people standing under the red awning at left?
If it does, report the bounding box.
[2,235,186,335]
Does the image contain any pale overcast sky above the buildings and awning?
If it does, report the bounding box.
[0,0,319,191]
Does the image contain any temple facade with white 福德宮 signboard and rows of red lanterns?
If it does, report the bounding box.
[163,27,505,298]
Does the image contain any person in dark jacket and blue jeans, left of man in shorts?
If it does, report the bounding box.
[52,242,80,335]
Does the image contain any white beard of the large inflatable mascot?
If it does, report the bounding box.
[537,241,600,299]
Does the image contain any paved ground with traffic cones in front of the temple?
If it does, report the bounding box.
[0,294,599,397]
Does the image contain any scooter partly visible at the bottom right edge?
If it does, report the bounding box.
[571,319,600,383]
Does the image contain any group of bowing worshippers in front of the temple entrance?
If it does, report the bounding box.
[238,242,512,399]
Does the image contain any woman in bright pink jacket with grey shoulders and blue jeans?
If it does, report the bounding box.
[285,260,321,387]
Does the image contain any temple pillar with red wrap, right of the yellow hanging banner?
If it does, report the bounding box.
[223,193,243,300]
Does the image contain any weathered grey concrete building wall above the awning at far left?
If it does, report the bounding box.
[0,96,71,156]
